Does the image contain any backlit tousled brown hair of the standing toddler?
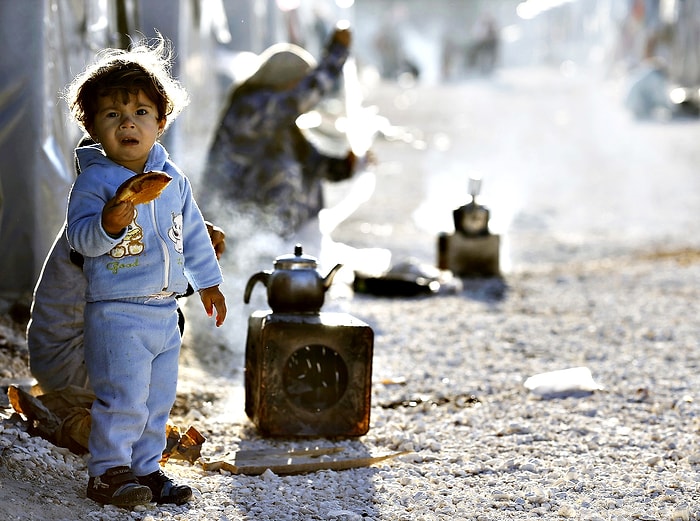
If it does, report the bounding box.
[64,34,189,132]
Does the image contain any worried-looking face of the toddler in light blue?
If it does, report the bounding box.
[90,90,165,174]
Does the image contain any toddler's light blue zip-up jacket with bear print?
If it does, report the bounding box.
[67,143,223,302]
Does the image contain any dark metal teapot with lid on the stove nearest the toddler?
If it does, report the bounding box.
[243,244,343,313]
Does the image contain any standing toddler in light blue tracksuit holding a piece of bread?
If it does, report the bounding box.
[66,36,226,507]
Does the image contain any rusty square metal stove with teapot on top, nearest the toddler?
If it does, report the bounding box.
[244,245,374,437]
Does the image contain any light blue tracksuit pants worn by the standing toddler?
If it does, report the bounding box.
[85,297,181,476]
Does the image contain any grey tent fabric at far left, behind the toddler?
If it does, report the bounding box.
[0,0,100,294]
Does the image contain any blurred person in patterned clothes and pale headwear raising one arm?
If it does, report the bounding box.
[200,22,357,254]
